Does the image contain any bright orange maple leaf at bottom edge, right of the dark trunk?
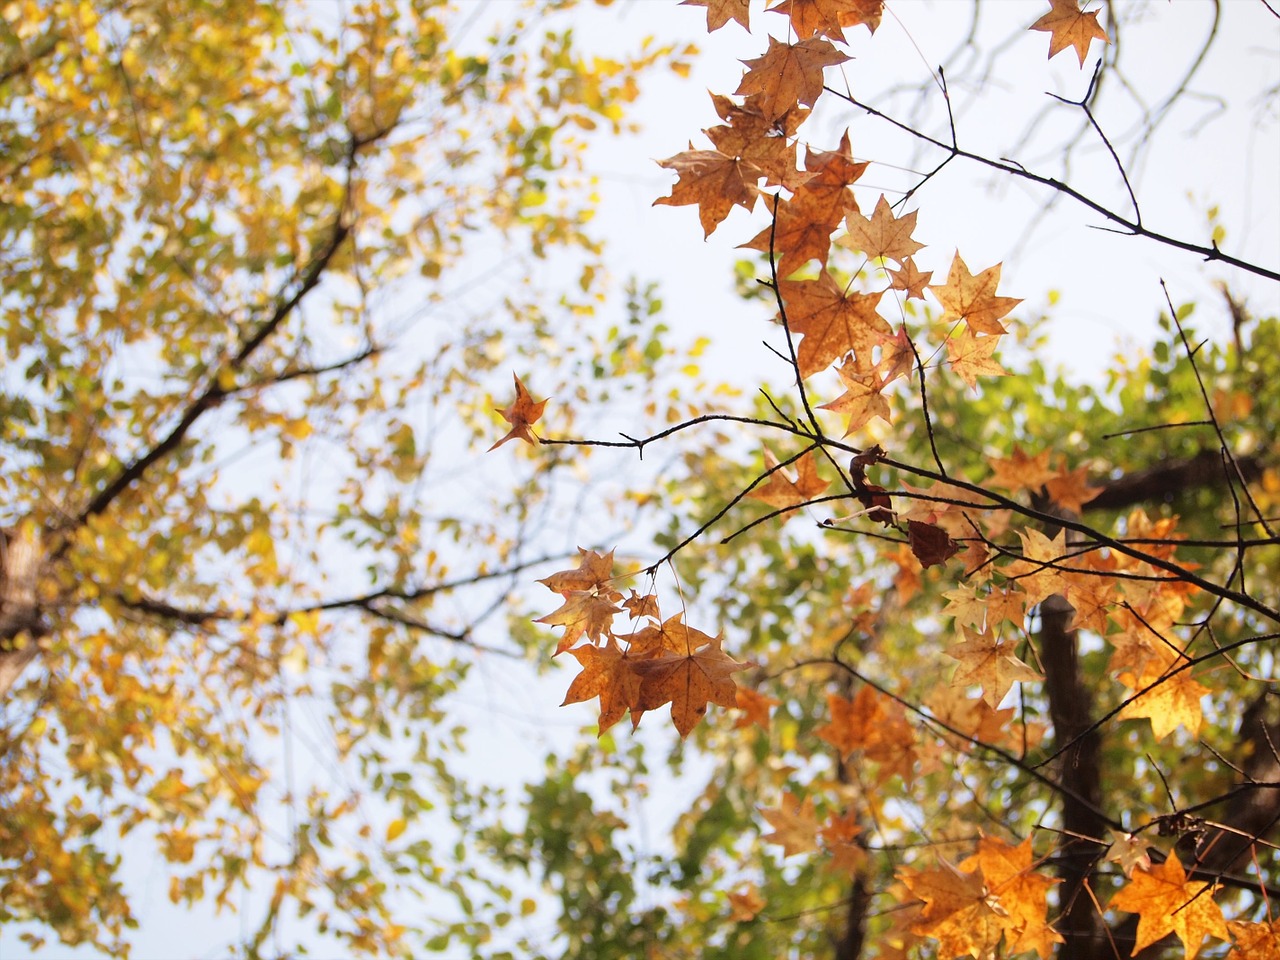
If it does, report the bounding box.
[1110,852,1230,960]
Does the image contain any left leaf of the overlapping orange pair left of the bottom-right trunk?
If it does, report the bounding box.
[897,860,1005,960]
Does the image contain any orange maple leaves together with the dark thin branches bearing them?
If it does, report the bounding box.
[494,0,1280,960]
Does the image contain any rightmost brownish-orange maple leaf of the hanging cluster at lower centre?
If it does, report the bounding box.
[632,625,748,737]
